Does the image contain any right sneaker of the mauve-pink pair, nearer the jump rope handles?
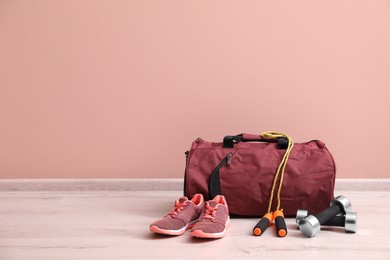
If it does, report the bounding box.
[191,195,229,238]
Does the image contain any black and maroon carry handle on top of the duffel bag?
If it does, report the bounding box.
[223,134,288,149]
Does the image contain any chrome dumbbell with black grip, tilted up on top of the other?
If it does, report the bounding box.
[298,196,351,237]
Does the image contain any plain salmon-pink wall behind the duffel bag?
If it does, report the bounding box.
[0,0,390,178]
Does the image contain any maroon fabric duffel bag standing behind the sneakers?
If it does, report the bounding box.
[184,134,336,217]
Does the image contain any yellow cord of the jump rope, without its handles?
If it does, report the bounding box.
[261,131,294,213]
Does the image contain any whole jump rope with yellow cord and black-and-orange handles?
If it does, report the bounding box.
[253,131,294,237]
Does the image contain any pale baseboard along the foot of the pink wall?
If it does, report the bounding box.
[0,178,390,192]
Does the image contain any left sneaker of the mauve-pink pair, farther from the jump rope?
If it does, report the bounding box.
[150,194,204,236]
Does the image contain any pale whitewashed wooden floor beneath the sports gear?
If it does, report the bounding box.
[0,188,390,260]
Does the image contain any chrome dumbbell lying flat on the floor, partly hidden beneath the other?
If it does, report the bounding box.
[295,209,357,233]
